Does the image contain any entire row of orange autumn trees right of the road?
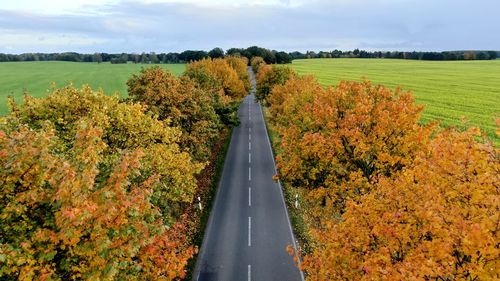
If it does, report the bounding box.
[251,58,500,280]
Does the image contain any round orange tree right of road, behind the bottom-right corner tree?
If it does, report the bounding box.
[268,77,430,211]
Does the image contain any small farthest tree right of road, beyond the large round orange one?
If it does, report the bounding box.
[255,65,297,105]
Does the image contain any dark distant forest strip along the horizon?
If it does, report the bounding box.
[0,46,500,64]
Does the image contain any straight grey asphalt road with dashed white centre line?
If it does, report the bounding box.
[193,66,304,281]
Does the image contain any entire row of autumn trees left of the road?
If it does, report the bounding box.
[0,57,250,280]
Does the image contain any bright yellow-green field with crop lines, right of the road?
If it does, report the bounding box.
[292,59,500,144]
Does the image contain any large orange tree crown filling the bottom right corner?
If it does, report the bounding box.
[303,130,500,280]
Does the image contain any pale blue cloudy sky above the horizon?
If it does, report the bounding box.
[0,0,500,54]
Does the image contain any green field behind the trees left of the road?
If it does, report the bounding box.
[0,61,185,115]
